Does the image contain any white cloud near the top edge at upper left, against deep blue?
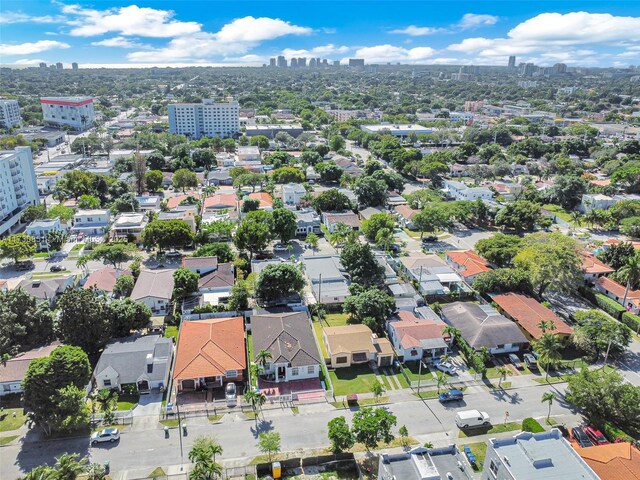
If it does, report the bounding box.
[62,5,201,38]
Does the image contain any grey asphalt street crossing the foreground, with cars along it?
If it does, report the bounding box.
[0,385,577,480]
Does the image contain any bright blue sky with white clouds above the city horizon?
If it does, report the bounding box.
[0,0,640,68]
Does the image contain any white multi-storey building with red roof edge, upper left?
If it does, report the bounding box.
[40,97,96,131]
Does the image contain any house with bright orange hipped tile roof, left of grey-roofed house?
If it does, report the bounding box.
[173,317,247,391]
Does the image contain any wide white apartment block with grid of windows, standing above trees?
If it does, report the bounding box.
[169,99,240,138]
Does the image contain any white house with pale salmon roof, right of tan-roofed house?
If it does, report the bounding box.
[387,311,449,362]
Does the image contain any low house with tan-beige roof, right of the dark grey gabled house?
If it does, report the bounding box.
[322,325,393,368]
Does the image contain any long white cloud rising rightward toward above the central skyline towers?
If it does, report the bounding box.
[127,17,313,62]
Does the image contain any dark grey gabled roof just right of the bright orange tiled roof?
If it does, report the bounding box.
[251,312,320,367]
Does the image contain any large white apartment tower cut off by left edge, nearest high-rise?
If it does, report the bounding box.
[0,147,40,237]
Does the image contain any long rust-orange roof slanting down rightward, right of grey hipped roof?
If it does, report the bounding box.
[491,292,573,341]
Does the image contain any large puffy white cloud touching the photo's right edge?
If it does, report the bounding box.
[447,12,640,65]
